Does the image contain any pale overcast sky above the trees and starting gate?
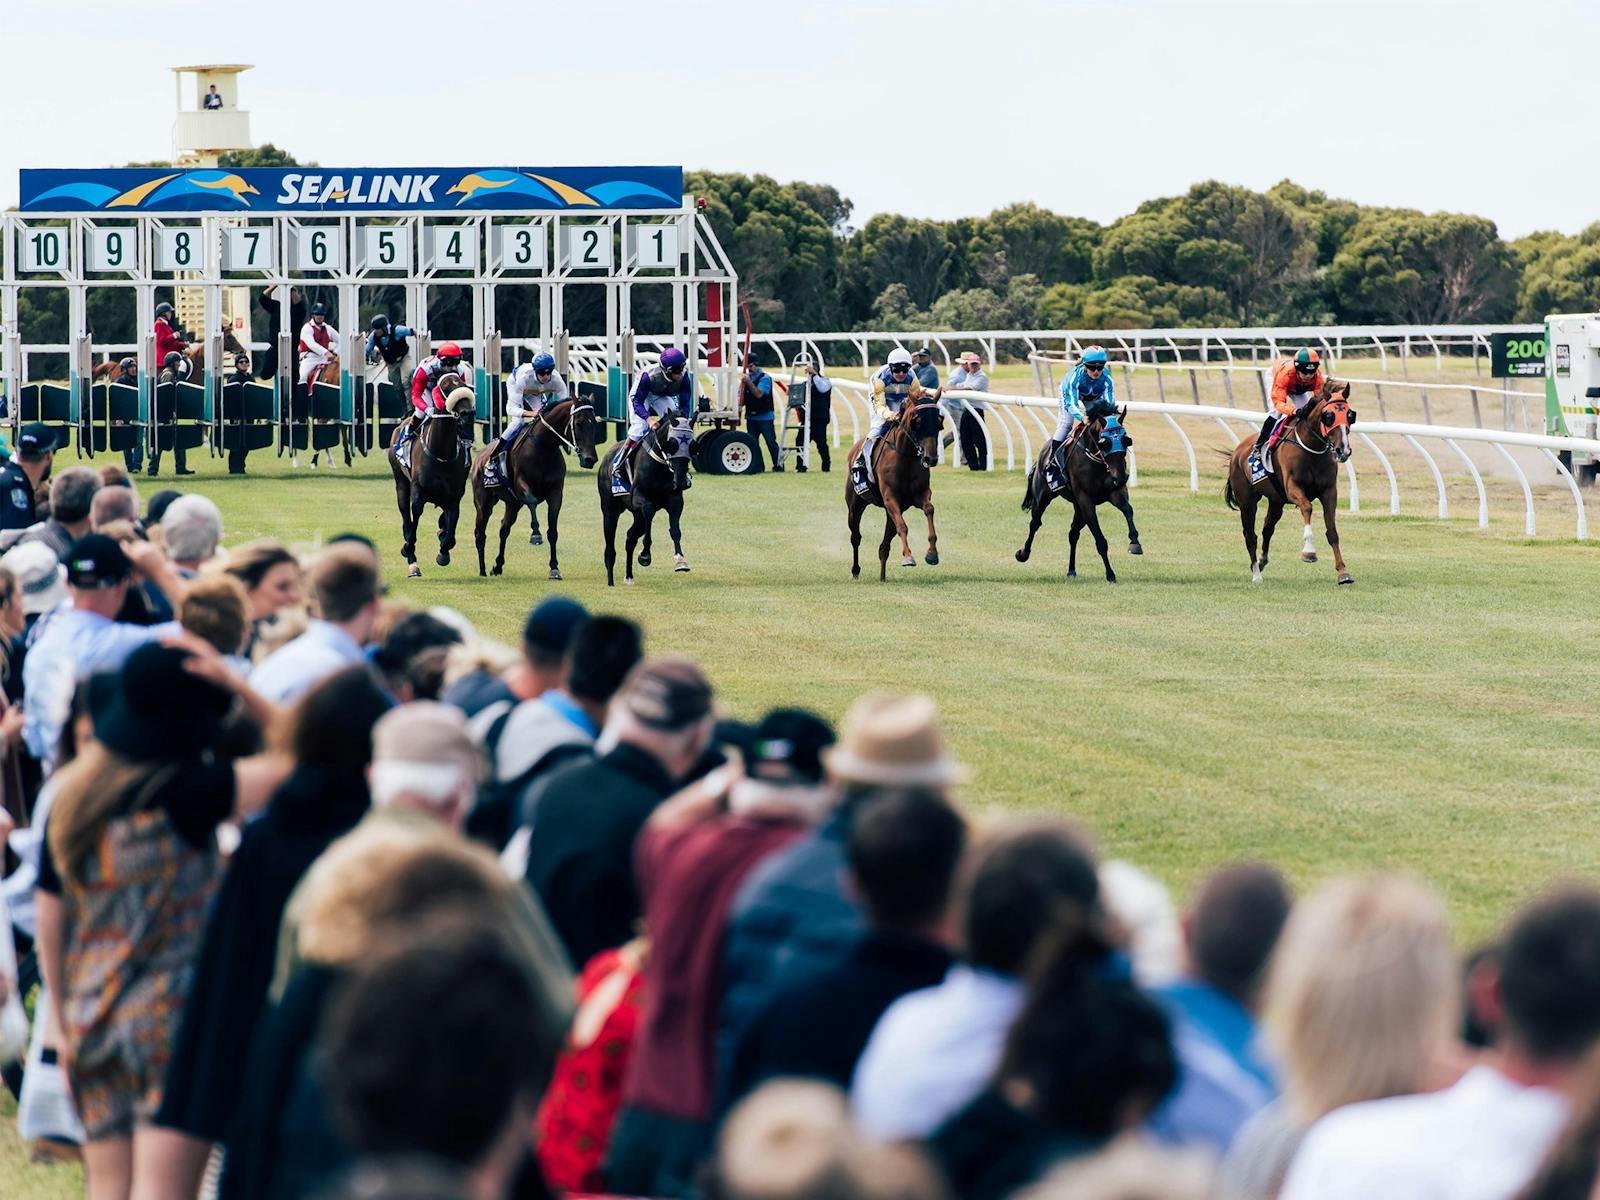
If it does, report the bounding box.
[0,0,1600,237]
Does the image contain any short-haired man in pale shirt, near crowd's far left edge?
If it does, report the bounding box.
[250,542,384,704]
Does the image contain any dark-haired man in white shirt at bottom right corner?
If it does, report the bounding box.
[1282,888,1600,1200]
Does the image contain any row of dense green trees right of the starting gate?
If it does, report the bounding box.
[686,171,1600,331]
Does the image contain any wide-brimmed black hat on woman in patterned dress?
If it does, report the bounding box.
[94,643,234,762]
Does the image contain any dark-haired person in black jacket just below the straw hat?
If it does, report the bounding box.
[722,789,966,1107]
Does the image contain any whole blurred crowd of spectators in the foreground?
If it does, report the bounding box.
[0,469,1600,1200]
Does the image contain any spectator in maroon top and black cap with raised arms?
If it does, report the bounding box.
[604,709,834,1195]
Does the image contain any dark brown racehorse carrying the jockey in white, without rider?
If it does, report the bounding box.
[472,400,597,579]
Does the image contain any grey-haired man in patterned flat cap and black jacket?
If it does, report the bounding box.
[526,658,712,966]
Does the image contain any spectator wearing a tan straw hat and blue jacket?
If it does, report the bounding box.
[717,696,965,1096]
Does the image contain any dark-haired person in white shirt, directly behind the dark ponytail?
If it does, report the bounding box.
[850,822,1099,1141]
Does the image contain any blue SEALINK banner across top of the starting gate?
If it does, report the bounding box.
[21,166,683,216]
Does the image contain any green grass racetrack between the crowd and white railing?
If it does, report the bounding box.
[0,418,1600,1197]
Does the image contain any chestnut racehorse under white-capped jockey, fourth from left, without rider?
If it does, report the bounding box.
[845,400,944,582]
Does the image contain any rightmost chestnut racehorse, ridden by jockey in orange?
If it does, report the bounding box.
[1222,379,1355,584]
